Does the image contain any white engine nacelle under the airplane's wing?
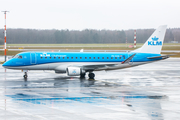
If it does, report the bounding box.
[67,67,82,76]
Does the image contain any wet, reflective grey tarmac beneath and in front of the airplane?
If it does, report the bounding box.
[0,58,180,120]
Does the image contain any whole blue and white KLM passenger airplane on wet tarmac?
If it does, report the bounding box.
[2,25,169,79]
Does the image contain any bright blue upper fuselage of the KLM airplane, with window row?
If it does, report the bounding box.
[3,52,161,70]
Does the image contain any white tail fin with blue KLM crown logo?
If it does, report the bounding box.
[132,25,167,54]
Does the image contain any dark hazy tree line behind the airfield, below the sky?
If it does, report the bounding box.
[0,28,180,44]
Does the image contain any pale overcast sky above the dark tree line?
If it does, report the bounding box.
[0,0,180,30]
